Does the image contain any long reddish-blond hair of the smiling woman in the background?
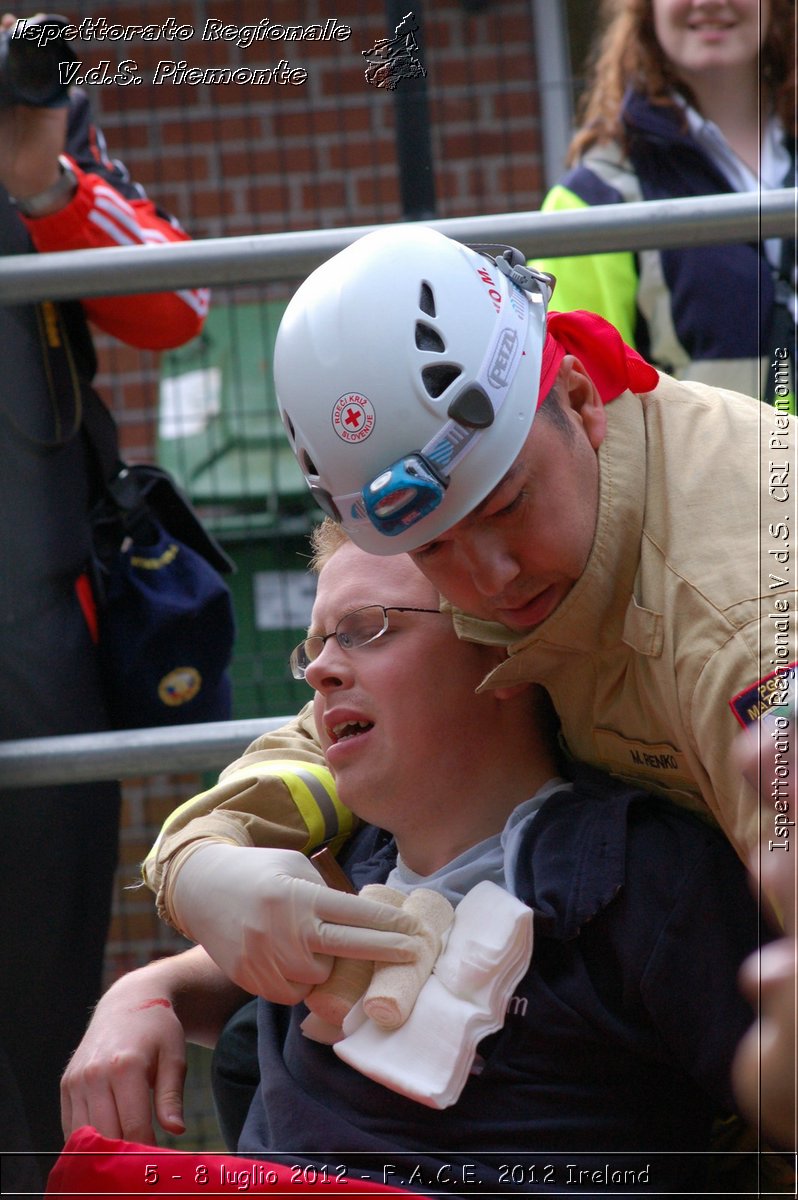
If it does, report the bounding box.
[566,0,797,166]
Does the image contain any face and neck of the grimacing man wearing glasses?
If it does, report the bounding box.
[305,544,542,874]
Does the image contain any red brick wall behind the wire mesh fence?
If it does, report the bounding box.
[63,0,542,457]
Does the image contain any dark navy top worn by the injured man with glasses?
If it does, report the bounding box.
[239,772,758,1195]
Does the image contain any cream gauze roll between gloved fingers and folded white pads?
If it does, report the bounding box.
[362,888,455,1030]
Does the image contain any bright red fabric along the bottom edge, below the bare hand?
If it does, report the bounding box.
[46,1126,422,1200]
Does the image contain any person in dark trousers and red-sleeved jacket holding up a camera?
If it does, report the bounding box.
[0,39,209,1190]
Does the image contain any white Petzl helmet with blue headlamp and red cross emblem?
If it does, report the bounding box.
[275,226,553,554]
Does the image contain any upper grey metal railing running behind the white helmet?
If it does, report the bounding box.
[0,187,798,304]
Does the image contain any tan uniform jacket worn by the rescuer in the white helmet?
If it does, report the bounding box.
[144,377,798,918]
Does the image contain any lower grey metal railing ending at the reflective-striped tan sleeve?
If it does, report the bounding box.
[0,716,289,803]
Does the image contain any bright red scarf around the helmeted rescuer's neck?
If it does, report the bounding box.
[538,308,659,406]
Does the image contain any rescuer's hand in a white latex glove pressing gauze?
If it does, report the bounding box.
[172,842,420,1004]
